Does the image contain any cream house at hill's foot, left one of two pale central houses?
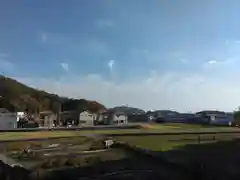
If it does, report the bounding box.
[79,110,98,126]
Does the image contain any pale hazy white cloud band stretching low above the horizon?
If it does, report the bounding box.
[15,72,240,112]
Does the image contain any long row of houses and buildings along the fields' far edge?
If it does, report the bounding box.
[0,108,234,129]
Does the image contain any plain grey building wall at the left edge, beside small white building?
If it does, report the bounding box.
[0,113,17,129]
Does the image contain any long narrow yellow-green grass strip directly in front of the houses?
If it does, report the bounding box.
[0,123,239,141]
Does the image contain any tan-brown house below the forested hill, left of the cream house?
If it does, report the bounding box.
[39,111,57,128]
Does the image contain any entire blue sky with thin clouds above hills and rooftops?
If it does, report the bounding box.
[0,0,240,112]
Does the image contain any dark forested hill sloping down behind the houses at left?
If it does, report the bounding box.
[0,75,105,113]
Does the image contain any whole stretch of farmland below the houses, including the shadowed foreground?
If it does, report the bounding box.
[0,124,240,180]
